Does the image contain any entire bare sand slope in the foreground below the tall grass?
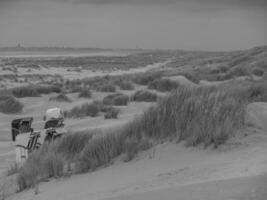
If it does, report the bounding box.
[7,103,267,200]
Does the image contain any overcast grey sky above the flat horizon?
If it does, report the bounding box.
[0,0,267,51]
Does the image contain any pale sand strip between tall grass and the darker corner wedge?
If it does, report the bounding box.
[7,129,267,200]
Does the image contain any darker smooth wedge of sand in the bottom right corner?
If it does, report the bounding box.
[105,174,267,200]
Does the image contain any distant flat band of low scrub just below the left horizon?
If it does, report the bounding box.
[2,51,169,71]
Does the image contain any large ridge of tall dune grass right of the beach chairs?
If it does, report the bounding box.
[15,84,247,190]
